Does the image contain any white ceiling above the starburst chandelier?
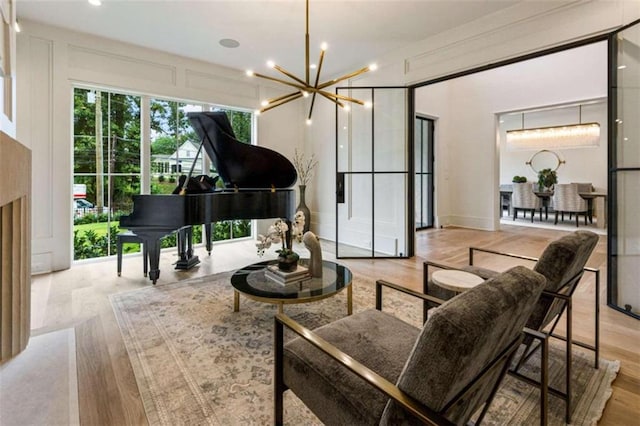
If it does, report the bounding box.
[16,0,521,77]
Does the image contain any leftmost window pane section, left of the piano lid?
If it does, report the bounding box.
[71,88,141,260]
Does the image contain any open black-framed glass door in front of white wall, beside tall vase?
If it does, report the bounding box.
[336,87,414,258]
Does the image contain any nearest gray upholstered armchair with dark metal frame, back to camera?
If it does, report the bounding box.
[274,266,545,425]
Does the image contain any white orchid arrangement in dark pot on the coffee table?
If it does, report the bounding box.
[256,211,305,271]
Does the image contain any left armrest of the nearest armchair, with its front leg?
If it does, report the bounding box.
[274,314,454,425]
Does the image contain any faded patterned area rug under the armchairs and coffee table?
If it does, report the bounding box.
[111,273,619,425]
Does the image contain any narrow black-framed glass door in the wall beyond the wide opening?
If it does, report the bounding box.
[413,116,434,230]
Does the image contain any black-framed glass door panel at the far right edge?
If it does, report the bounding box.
[607,21,640,319]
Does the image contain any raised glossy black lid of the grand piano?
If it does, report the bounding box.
[187,111,298,189]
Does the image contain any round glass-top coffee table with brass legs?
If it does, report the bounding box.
[231,259,353,315]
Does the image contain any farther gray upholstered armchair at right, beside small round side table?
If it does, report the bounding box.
[424,231,600,423]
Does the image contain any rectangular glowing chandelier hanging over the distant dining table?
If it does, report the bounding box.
[507,105,600,149]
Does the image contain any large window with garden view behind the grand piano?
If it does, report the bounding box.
[72,88,252,260]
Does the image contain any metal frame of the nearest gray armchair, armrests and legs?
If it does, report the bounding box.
[274,280,524,425]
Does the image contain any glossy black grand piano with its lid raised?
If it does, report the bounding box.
[120,111,297,284]
